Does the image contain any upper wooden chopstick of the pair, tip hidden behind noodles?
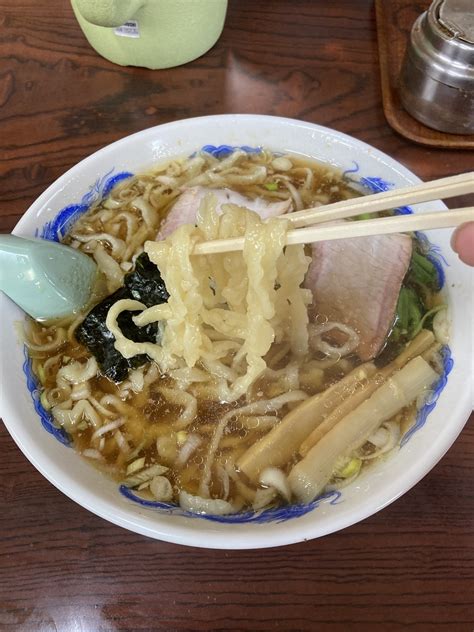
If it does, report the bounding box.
[279,171,474,227]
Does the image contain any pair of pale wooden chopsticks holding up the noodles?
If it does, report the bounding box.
[193,172,474,255]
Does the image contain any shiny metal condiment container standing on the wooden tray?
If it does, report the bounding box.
[399,0,474,134]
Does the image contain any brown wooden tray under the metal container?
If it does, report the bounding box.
[375,0,474,149]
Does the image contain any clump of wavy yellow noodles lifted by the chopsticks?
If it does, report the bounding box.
[107,195,311,401]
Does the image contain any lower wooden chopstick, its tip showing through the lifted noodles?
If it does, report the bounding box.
[193,207,474,255]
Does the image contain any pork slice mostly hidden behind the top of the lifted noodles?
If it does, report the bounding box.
[156,186,291,240]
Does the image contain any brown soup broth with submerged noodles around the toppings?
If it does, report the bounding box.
[27,151,440,511]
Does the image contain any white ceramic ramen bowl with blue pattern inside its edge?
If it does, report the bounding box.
[0,115,472,549]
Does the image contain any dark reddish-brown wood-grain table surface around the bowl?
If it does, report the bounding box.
[0,0,474,632]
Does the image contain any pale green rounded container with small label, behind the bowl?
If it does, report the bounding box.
[71,0,227,69]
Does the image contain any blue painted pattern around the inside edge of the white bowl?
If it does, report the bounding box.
[23,145,454,524]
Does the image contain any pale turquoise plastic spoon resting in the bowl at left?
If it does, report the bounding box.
[0,235,97,320]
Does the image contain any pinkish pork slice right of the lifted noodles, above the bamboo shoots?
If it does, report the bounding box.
[305,234,412,361]
